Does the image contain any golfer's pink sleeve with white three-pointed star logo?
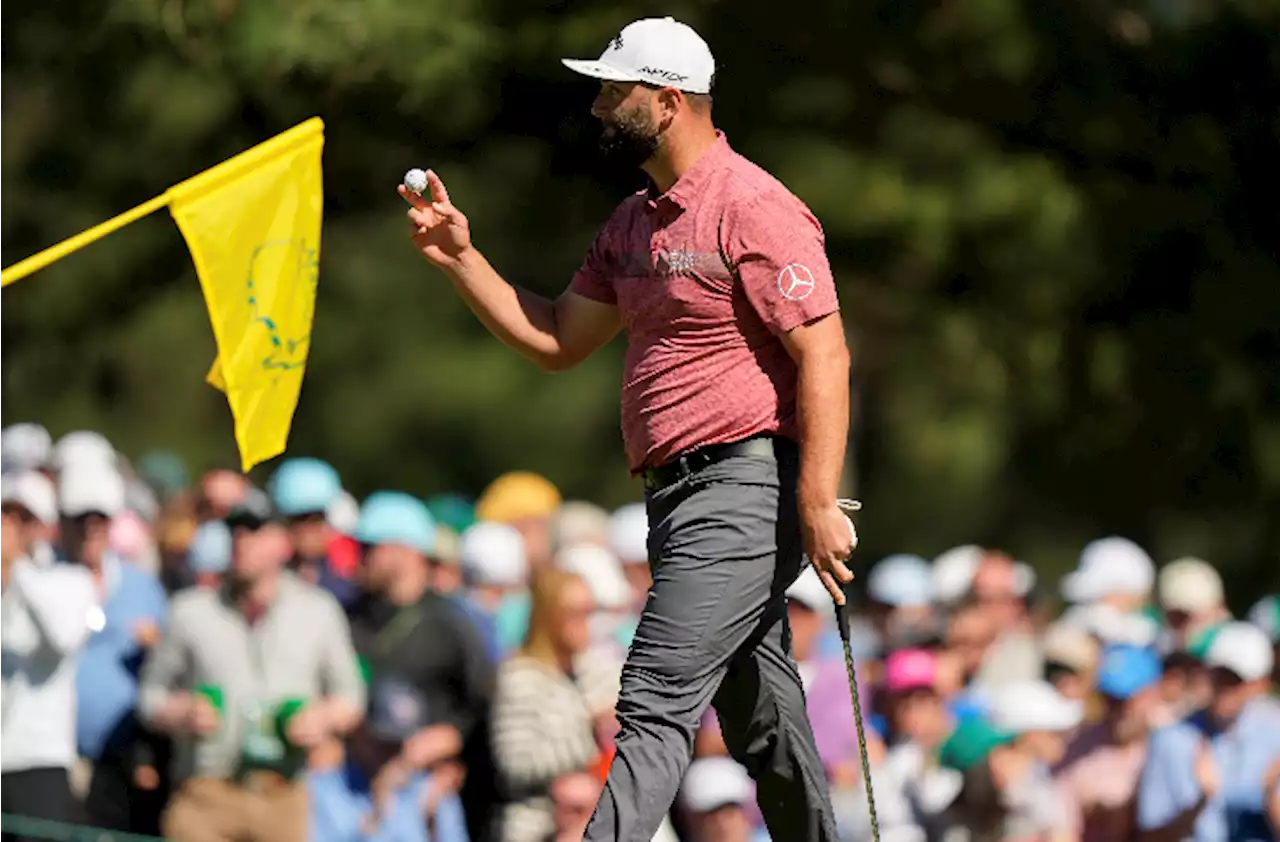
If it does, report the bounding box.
[723,192,840,334]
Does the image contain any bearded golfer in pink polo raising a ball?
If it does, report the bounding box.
[401,18,852,842]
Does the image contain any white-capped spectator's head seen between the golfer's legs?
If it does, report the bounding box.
[680,758,768,842]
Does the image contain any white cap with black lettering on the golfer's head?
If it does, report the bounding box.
[562,17,716,93]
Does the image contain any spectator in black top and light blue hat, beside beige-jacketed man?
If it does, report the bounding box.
[348,491,497,842]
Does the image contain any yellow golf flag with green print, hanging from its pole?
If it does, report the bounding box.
[168,118,324,471]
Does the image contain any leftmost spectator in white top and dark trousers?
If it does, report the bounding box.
[0,465,102,834]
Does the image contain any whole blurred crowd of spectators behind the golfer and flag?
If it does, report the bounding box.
[0,424,1280,842]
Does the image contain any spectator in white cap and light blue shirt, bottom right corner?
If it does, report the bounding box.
[1137,622,1280,842]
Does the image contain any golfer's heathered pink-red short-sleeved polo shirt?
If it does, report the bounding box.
[570,134,840,471]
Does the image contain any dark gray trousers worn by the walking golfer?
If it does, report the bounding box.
[584,441,837,842]
